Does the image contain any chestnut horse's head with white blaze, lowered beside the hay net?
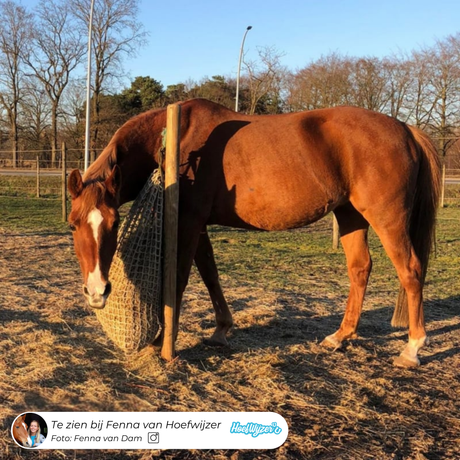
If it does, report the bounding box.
[69,166,121,308]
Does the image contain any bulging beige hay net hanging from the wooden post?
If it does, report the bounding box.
[96,169,164,352]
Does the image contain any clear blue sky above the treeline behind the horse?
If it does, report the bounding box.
[22,0,460,87]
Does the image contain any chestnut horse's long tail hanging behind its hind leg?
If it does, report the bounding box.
[391,126,441,327]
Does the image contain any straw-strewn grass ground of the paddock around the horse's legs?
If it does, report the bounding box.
[0,197,460,460]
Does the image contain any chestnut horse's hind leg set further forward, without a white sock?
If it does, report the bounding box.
[322,204,372,349]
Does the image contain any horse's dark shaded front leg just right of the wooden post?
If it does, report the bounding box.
[195,230,233,345]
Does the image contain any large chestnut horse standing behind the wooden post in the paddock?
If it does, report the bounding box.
[69,99,440,366]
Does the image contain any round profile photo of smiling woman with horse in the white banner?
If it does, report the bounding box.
[11,412,48,449]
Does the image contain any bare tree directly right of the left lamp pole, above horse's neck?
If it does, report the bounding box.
[70,0,147,161]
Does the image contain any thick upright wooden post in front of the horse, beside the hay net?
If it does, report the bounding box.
[161,104,181,361]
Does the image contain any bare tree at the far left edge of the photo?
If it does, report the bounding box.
[0,0,32,167]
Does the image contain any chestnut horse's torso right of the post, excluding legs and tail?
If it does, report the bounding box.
[175,100,419,230]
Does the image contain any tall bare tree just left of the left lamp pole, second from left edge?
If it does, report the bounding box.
[24,0,85,166]
